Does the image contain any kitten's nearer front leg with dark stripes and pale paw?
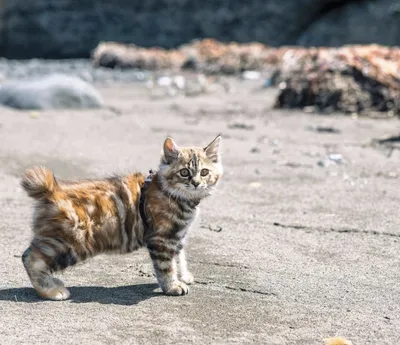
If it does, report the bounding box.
[147,241,189,296]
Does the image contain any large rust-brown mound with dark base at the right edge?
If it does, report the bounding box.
[275,45,400,115]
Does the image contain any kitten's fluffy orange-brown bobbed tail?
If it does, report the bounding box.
[21,166,57,199]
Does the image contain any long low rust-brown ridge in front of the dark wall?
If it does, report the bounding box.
[92,39,279,74]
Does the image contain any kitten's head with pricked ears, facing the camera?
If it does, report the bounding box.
[159,136,222,200]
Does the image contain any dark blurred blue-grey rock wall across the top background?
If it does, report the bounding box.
[0,0,400,58]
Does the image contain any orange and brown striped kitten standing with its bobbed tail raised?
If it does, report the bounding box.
[21,135,223,300]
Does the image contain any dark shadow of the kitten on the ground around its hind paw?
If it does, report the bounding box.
[0,284,161,305]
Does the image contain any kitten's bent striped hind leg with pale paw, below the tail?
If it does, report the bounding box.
[22,239,77,300]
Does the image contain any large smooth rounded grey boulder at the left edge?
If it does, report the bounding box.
[0,74,104,109]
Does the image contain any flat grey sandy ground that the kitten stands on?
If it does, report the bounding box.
[0,82,400,345]
